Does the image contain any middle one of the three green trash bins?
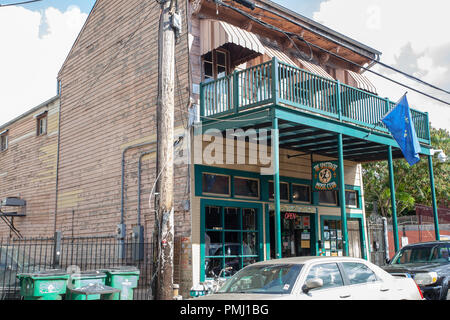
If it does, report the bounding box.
[66,271,106,300]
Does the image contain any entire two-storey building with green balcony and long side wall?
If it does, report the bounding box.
[0,0,438,293]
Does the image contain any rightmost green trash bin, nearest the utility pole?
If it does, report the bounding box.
[101,266,140,300]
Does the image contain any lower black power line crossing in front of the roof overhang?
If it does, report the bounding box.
[214,0,450,105]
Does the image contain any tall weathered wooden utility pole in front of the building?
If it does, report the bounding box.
[156,0,175,300]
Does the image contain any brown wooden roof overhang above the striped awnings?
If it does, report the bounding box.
[191,0,381,71]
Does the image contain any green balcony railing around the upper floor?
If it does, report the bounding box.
[200,58,430,143]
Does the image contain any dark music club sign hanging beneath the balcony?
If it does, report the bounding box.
[312,161,338,191]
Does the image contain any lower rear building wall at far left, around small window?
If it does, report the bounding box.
[0,97,59,238]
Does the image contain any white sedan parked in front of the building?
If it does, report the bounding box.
[195,257,423,300]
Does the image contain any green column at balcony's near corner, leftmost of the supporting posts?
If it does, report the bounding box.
[272,117,281,259]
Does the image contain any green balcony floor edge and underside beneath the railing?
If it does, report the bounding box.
[202,106,431,163]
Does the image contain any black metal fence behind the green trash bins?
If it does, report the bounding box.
[0,233,156,300]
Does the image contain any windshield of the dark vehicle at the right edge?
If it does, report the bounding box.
[392,245,450,264]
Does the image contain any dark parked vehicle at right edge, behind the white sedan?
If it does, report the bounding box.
[383,241,450,300]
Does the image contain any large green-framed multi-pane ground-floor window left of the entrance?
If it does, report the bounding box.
[204,206,260,278]
